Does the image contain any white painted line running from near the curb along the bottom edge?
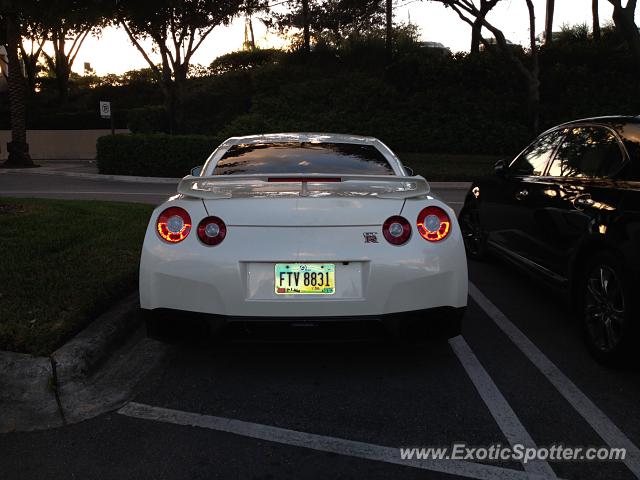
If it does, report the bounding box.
[118,402,549,480]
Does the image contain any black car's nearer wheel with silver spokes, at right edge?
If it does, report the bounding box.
[578,253,637,364]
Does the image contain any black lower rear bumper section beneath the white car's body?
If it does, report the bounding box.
[141,307,466,337]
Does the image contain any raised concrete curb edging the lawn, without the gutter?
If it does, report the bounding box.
[0,293,141,432]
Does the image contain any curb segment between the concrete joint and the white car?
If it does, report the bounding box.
[50,292,141,384]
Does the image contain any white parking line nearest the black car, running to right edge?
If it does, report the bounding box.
[469,282,640,478]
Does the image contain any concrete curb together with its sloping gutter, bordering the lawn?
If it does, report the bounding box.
[0,292,152,433]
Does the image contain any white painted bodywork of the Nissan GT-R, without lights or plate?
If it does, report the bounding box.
[140,134,467,319]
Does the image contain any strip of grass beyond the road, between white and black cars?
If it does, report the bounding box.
[398,153,506,182]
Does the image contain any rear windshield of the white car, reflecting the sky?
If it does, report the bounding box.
[213,142,394,175]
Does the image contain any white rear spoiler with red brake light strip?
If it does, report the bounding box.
[178,174,430,200]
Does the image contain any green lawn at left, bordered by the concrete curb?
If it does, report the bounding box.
[0,198,152,355]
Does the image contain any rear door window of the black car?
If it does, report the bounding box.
[549,127,624,178]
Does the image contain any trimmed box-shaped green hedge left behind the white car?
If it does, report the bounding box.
[96,133,220,177]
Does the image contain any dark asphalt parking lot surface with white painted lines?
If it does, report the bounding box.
[0,169,640,479]
